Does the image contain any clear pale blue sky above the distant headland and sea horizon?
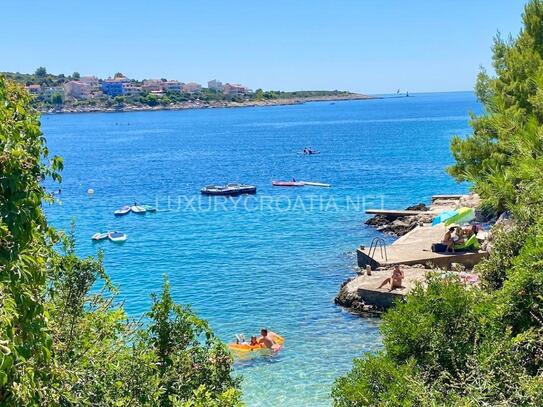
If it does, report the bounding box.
[0,0,525,93]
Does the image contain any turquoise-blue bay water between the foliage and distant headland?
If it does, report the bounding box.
[42,93,480,406]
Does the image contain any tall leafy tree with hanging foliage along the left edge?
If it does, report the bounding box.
[0,76,62,406]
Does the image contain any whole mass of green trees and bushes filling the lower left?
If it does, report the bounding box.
[0,75,240,407]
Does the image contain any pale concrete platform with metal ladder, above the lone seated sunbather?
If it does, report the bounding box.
[356,224,488,269]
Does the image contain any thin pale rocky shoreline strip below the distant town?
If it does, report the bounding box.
[38,93,380,114]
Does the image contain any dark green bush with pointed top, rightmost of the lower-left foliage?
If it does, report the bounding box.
[143,280,239,406]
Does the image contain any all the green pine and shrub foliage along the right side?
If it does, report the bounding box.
[333,0,543,406]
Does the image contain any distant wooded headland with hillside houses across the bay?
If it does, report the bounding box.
[1,67,369,113]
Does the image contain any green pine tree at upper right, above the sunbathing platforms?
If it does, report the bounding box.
[449,0,543,217]
